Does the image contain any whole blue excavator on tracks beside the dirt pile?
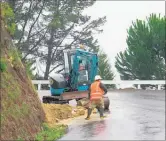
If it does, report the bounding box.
[43,49,109,110]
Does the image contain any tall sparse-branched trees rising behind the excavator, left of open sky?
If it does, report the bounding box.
[8,0,106,79]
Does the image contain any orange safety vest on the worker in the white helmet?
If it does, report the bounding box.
[90,81,104,100]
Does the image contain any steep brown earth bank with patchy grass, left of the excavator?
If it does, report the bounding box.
[0,21,45,140]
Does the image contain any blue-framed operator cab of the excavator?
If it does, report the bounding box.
[64,49,98,91]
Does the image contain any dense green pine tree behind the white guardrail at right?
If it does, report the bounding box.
[115,14,166,80]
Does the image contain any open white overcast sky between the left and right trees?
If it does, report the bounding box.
[84,1,165,80]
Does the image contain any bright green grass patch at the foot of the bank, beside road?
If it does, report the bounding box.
[35,123,67,141]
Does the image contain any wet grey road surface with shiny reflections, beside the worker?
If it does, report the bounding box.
[60,90,165,140]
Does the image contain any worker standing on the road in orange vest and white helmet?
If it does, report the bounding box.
[85,75,107,120]
